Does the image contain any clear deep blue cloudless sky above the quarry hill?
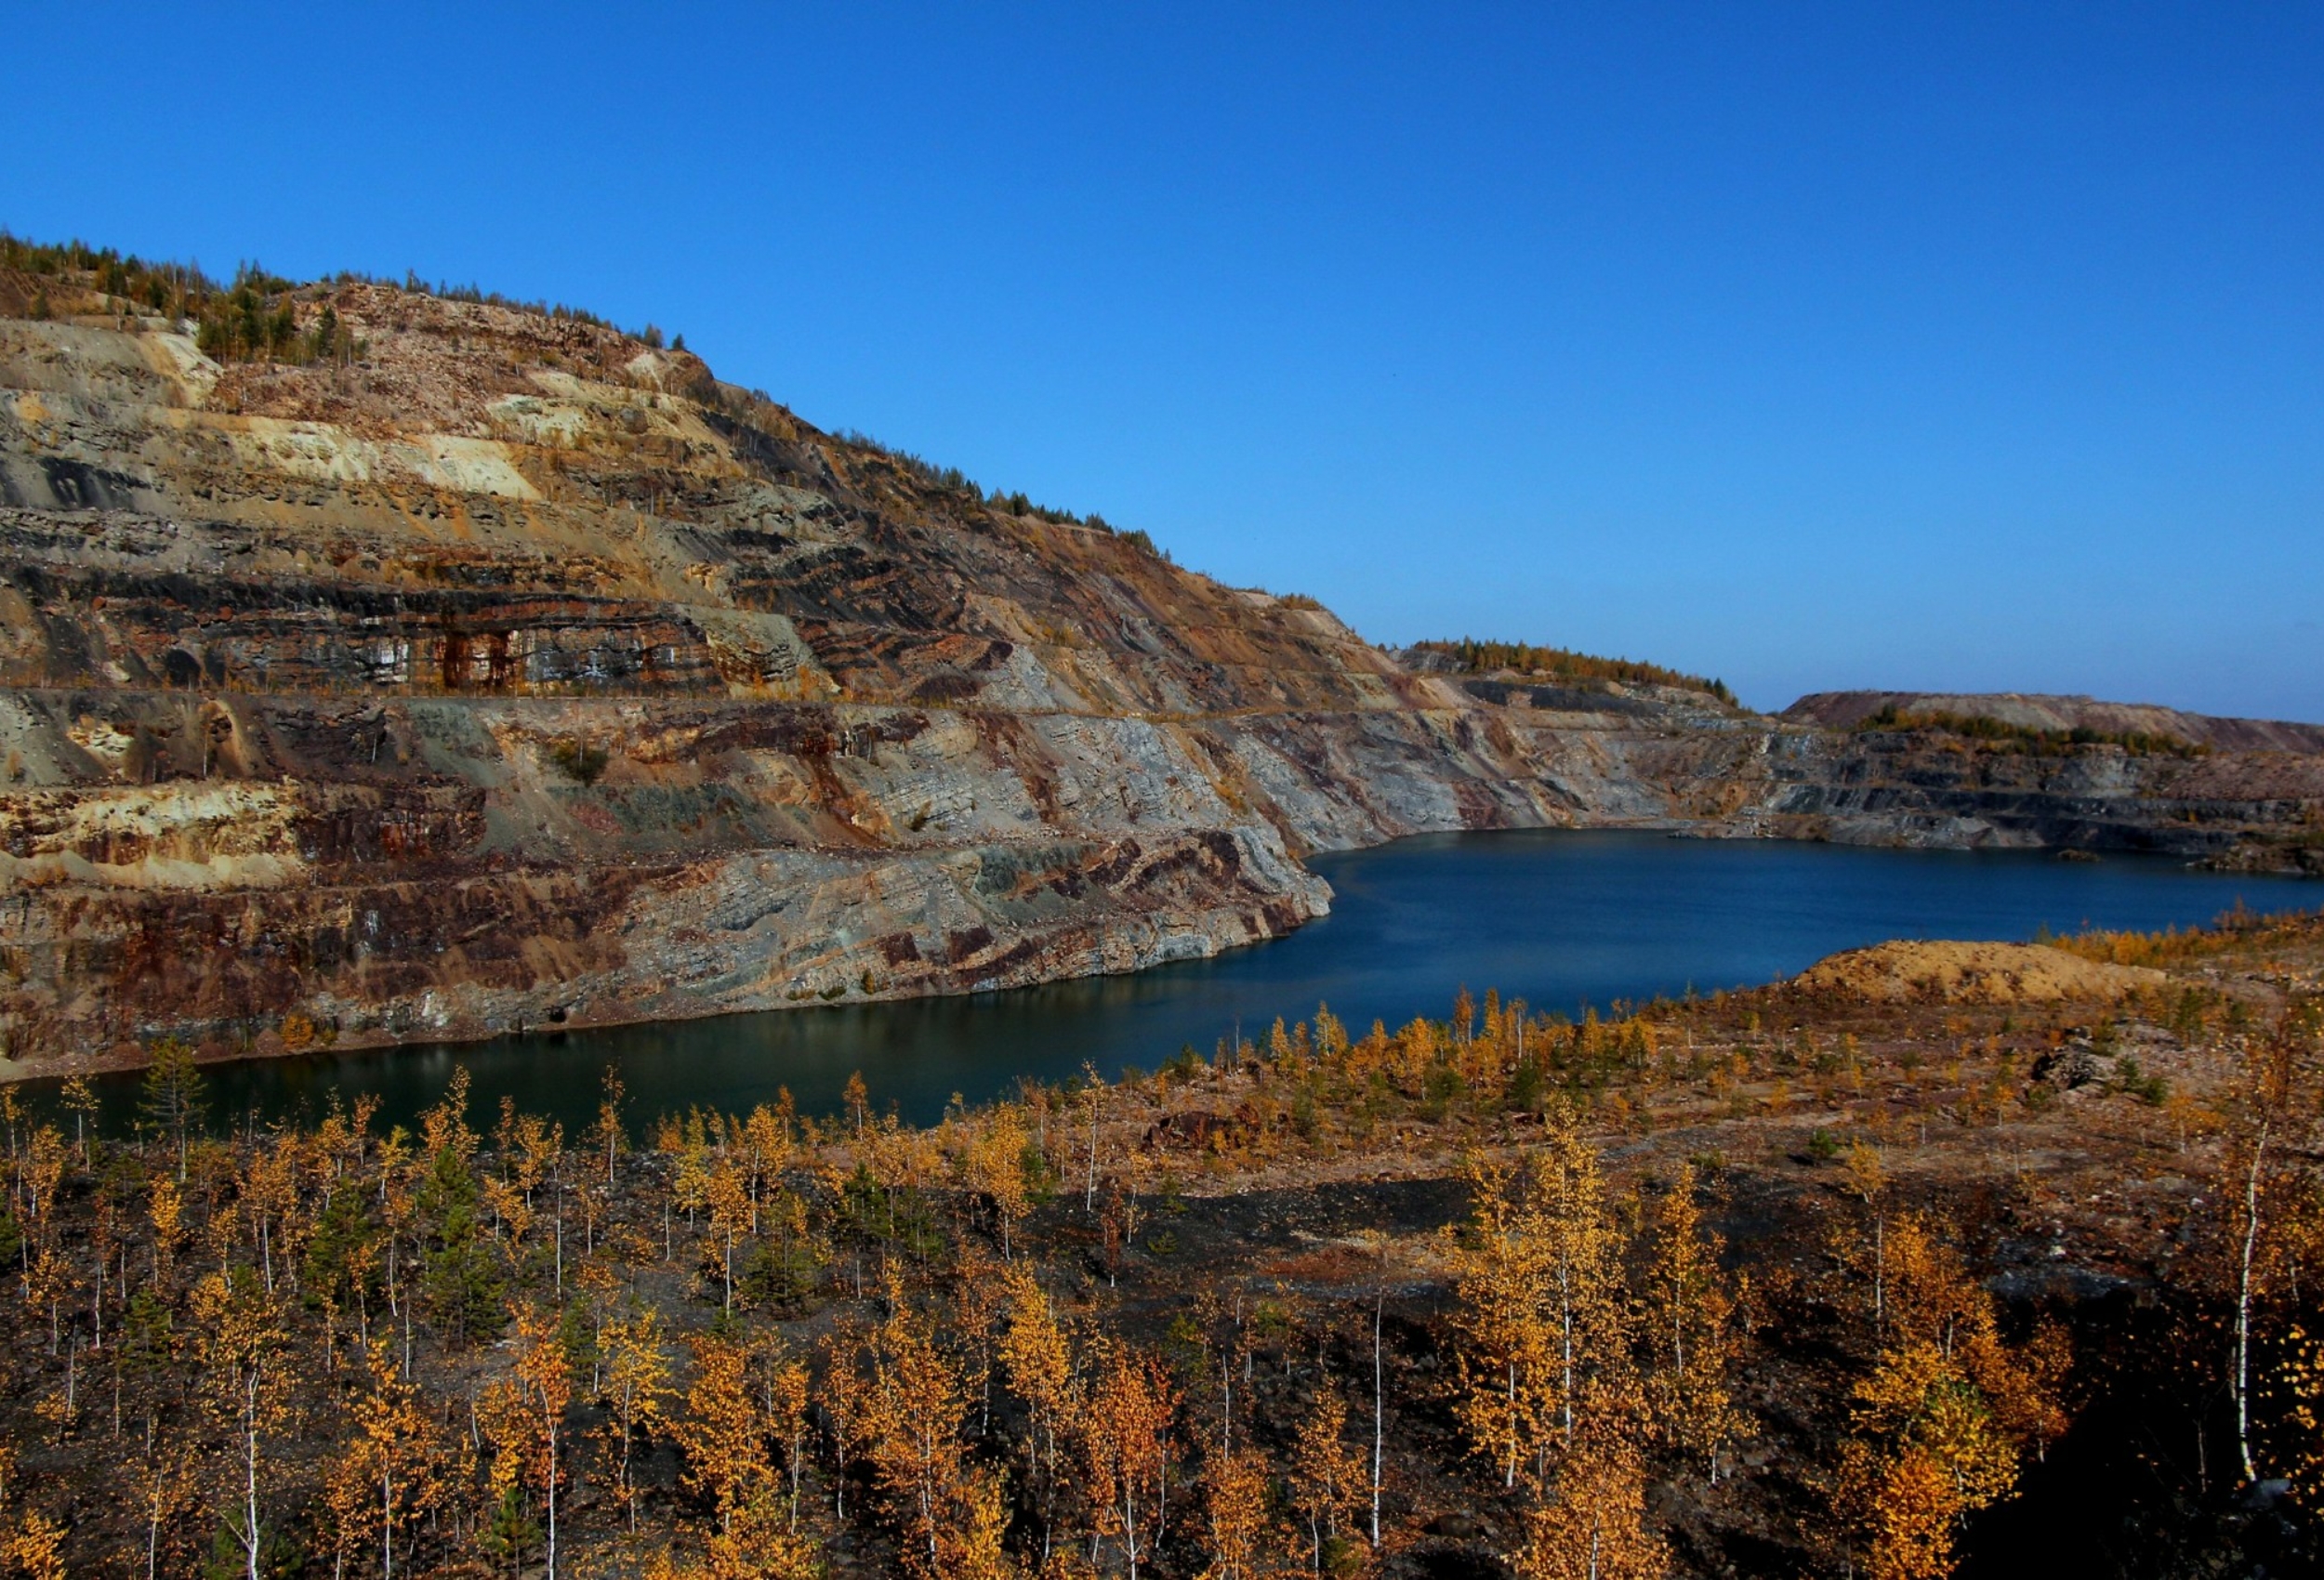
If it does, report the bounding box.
[0,3,2324,718]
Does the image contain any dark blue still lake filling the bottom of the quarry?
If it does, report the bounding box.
[107,830,2324,1132]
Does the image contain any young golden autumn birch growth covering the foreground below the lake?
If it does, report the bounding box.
[68,939,2324,1580]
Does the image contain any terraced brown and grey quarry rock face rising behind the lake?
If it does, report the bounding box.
[0,279,2324,1060]
